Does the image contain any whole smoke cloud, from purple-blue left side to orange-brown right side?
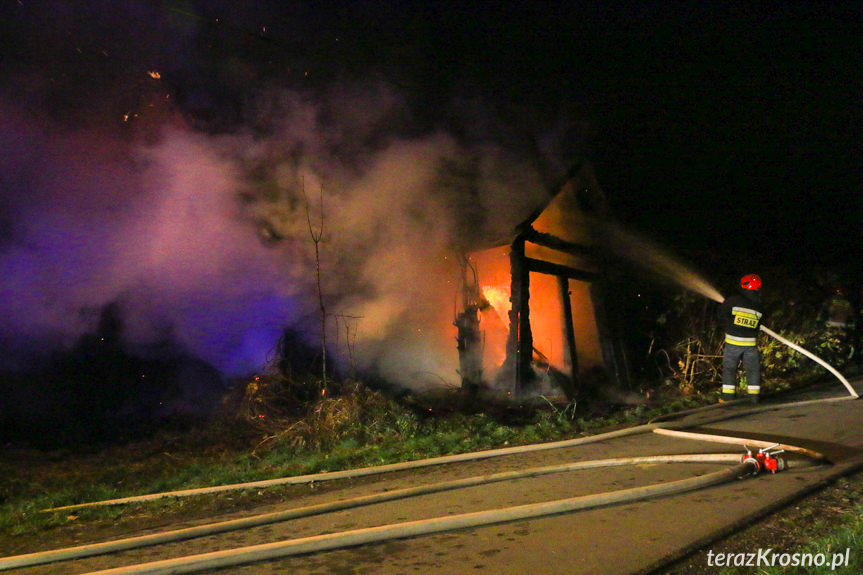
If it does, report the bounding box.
[0,3,555,385]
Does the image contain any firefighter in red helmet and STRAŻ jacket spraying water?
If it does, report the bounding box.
[719,274,764,403]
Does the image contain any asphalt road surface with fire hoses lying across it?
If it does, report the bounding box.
[8,380,863,575]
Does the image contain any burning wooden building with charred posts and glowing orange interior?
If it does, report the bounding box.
[455,164,628,398]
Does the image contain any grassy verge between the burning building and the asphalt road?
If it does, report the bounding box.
[0,387,703,552]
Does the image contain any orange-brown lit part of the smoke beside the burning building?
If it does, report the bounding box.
[226,91,547,385]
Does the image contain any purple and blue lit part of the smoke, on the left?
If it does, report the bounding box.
[0,110,304,373]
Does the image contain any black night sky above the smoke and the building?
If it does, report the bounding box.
[8,0,863,251]
